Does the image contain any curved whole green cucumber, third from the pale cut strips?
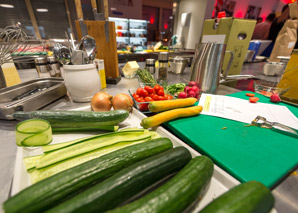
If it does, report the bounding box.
[110,156,213,213]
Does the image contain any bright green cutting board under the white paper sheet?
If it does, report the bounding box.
[165,91,298,187]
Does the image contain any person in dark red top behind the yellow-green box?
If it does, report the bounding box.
[252,13,275,40]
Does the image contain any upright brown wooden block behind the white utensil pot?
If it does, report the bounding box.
[76,21,119,78]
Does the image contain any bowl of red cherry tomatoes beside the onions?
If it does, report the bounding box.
[129,84,173,112]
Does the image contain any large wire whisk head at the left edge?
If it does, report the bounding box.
[0,26,43,65]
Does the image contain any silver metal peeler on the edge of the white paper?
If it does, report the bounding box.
[251,116,298,138]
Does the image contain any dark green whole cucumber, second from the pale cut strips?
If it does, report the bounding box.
[48,147,191,213]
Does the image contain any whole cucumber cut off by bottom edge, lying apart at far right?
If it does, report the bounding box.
[201,181,274,213]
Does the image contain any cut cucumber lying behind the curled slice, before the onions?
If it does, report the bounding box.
[13,110,129,129]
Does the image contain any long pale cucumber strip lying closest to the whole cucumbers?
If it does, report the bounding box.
[30,139,150,183]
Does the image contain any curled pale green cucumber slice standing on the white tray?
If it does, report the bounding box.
[16,119,52,146]
